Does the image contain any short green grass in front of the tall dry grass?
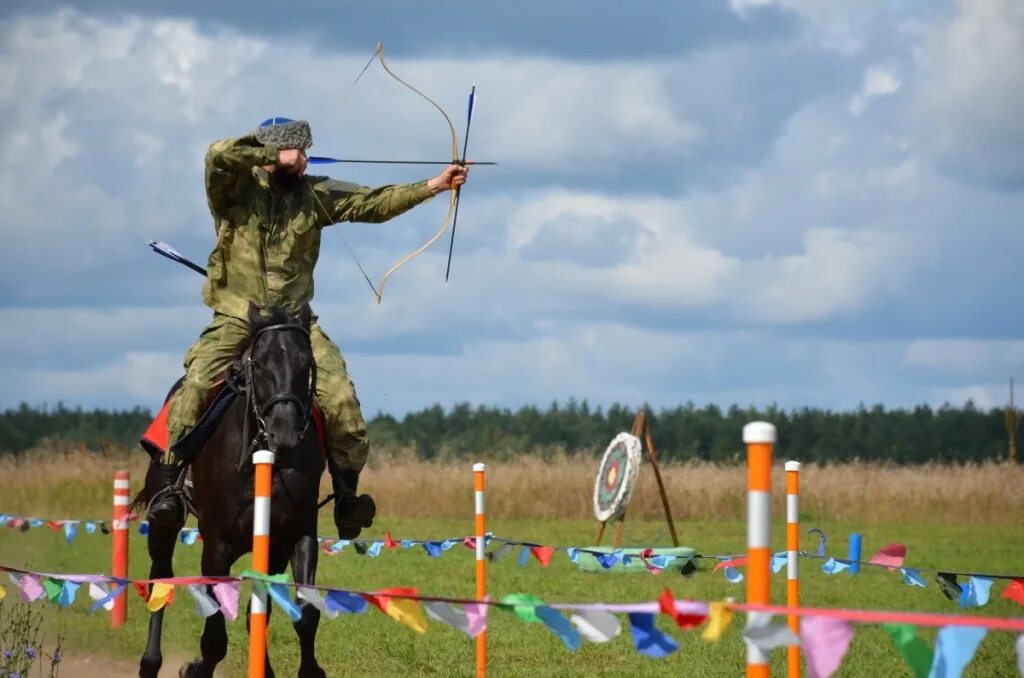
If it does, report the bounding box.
[0,513,1024,677]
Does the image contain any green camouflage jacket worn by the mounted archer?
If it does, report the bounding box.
[203,135,431,320]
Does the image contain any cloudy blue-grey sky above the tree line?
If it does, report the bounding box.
[0,0,1024,416]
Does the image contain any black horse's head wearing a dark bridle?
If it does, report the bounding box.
[243,305,316,452]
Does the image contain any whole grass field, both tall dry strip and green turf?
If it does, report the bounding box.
[0,453,1024,676]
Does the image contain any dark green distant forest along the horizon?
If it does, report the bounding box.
[0,400,1008,464]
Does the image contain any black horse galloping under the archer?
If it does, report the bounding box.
[136,307,327,678]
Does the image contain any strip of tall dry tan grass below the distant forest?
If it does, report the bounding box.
[0,447,1024,525]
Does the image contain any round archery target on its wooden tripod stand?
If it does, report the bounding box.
[594,410,679,549]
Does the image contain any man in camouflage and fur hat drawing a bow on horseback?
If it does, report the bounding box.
[146,118,467,539]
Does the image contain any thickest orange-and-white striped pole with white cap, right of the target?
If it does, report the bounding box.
[743,421,775,678]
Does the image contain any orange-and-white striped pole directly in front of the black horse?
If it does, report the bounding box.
[249,450,273,678]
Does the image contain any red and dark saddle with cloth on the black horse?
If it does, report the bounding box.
[139,377,327,464]
